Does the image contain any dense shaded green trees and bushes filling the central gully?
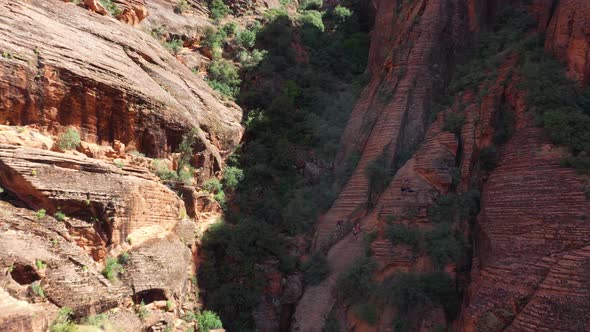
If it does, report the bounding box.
[199,2,368,331]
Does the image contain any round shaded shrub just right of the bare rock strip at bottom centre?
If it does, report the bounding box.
[338,257,377,303]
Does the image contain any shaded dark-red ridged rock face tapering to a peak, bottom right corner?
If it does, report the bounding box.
[462,68,590,331]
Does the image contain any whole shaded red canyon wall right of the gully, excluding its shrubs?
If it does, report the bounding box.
[292,1,590,331]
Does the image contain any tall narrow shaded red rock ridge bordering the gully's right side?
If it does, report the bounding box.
[292,1,467,331]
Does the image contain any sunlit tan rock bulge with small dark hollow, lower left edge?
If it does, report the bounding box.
[0,202,127,321]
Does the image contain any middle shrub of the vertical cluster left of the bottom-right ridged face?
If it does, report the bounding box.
[424,224,465,268]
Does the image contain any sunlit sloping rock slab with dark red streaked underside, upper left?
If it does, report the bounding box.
[0,0,242,171]
